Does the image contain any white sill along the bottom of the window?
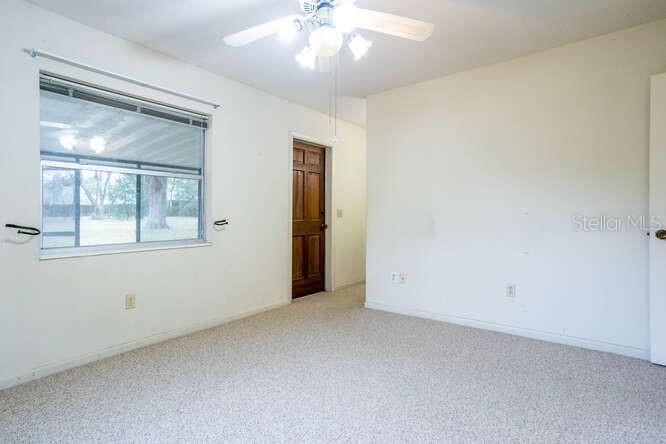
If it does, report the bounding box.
[39,241,213,261]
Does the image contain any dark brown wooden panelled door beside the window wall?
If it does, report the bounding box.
[291,140,327,298]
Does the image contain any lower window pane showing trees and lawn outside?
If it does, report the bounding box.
[42,169,200,248]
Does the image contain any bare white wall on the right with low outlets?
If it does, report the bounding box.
[367,21,666,357]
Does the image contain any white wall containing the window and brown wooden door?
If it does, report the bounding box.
[0,0,365,387]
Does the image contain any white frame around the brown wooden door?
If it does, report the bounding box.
[285,131,335,300]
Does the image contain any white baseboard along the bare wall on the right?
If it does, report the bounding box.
[365,301,650,360]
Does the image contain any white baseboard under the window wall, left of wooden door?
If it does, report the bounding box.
[0,300,291,390]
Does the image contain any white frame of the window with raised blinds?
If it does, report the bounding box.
[38,71,212,260]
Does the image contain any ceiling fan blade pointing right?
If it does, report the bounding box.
[356,8,435,42]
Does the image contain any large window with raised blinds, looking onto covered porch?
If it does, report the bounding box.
[40,75,208,251]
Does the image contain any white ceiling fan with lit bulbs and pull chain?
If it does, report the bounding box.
[224,0,435,69]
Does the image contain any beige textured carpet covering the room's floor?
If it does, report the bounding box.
[0,287,666,443]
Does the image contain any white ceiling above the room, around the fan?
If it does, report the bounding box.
[26,0,666,126]
